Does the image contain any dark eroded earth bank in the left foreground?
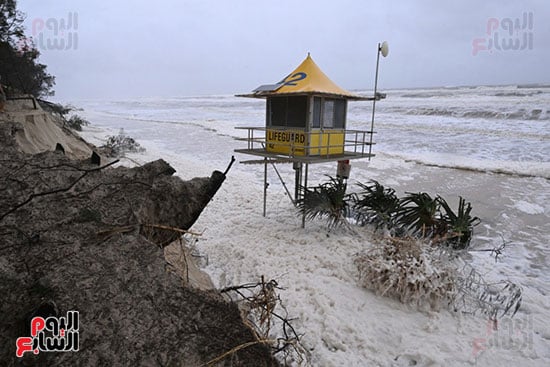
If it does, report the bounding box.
[0,103,276,366]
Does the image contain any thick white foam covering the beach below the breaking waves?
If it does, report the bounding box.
[78,112,550,367]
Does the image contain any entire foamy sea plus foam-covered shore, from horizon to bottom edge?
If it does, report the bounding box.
[72,85,550,366]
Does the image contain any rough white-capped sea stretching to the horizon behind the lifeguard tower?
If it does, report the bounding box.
[77,85,550,178]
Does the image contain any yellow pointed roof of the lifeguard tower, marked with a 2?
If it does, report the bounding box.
[239,53,370,100]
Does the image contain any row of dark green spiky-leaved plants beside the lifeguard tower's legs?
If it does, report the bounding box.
[297,176,480,249]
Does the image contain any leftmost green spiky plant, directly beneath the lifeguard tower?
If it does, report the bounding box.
[296,176,350,228]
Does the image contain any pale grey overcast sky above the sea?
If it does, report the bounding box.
[18,0,550,100]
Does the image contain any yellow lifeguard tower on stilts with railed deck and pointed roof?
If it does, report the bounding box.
[235,45,385,225]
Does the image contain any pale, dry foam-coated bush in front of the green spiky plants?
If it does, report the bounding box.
[354,237,522,321]
